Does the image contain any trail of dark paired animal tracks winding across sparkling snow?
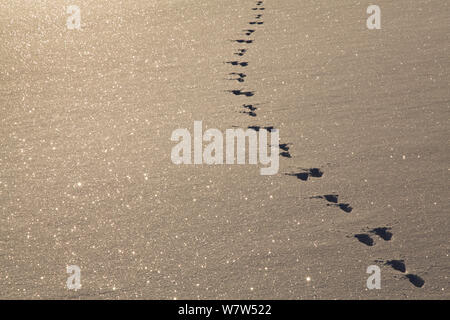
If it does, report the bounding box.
[225,1,425,288]
